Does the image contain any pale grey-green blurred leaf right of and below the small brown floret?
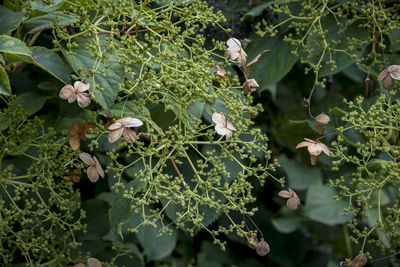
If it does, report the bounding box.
[304,184,353,225]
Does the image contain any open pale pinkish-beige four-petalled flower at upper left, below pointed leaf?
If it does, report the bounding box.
[60,81,91,108]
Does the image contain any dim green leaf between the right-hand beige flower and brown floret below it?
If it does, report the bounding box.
[279,154,322,190]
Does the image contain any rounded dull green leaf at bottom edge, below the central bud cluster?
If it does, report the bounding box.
[137,222,178,262]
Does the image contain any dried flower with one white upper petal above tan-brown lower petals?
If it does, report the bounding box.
[108,117,143,143]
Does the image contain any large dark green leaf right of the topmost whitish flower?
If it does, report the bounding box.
[246,36,298,91]
